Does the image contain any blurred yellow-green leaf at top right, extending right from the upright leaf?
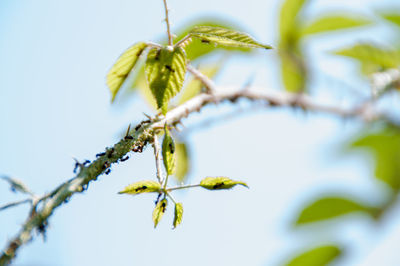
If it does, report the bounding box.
[301,14,371,36]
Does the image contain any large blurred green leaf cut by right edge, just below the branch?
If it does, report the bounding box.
[350,126,400,190]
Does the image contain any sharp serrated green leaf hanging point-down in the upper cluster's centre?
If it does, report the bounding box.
[145,47,186,114]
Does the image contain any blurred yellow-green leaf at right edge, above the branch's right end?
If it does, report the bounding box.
[334,44,400,74]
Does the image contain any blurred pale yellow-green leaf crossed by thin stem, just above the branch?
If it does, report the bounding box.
[178,64,221,105]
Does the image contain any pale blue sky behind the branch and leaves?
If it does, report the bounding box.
[0,0,400,266]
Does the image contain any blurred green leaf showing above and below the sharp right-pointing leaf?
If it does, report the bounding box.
[176,18,251,61]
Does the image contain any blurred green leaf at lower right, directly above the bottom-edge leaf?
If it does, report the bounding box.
[295,196,374,225]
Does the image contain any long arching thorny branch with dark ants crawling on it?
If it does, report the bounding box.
[0,70,389,265]
